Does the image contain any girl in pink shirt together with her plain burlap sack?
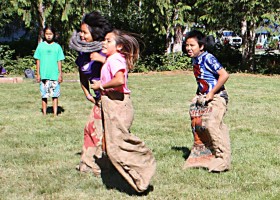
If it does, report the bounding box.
[91,30,156,192]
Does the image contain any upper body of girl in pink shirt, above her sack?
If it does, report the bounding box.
[92,30,139,94]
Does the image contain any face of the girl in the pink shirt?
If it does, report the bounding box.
[102,32,122,56]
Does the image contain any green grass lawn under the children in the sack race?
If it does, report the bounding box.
[0,73,280,200]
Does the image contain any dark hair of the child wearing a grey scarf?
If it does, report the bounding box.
[82,11,113,41]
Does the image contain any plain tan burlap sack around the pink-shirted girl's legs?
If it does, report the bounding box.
[101,93,156,192]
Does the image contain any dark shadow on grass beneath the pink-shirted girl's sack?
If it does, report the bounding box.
[96,155,154,196]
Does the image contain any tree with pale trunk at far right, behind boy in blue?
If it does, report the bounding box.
[192,0,279,71]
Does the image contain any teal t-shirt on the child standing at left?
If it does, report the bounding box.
[34,42,65,81]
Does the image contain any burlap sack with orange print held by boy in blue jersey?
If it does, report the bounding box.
[183,93,231,172]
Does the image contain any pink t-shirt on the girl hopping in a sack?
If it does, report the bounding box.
[100,53,130,94]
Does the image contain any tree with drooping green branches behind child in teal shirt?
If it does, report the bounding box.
[10,0,98,48]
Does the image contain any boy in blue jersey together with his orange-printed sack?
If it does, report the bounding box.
[183,30,231,172]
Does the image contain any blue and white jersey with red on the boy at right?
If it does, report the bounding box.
[192,51,224,94]
